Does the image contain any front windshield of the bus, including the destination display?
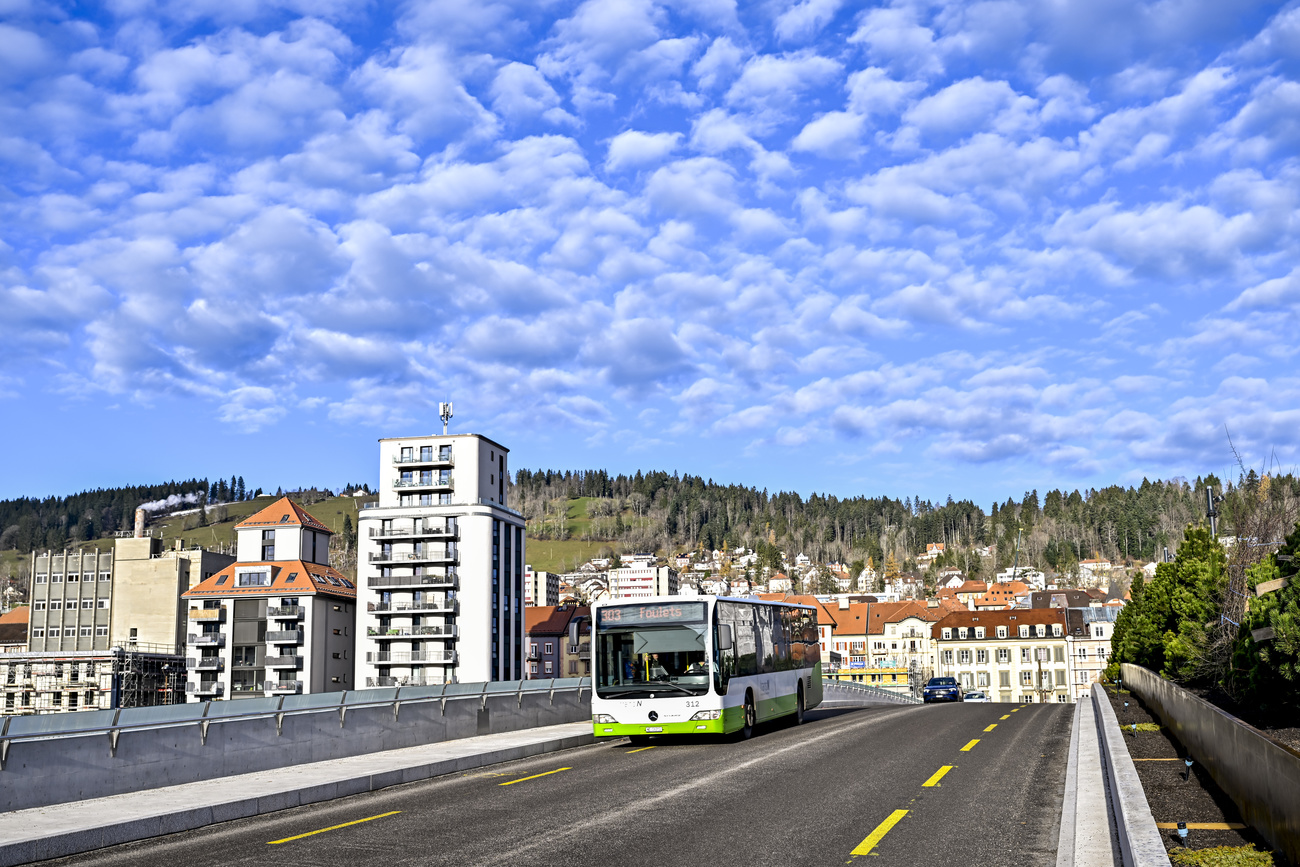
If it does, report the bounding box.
[595,602,710,698]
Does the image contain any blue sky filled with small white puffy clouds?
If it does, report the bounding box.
[0,0,1300,506]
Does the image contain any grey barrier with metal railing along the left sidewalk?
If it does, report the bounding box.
[0,677,592,811]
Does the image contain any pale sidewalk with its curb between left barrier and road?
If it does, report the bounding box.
[0,721,595,867]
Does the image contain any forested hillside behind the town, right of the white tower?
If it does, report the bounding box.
[511,469,1300,575]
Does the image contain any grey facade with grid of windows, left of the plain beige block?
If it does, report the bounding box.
[27,549,113,653]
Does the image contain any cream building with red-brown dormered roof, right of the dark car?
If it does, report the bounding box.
[931,608,1075,702]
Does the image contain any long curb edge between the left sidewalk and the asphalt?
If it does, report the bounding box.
[0,732,595,867]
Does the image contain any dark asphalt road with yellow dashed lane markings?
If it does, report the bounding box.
[47,705,1074,867]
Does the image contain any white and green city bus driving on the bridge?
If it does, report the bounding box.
[592,597,822,742]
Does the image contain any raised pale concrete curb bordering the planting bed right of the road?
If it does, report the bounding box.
[1092,684,1170,867]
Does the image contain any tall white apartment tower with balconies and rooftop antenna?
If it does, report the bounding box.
[356,434,525,686]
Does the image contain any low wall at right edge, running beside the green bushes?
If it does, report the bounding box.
[1121,664,1300,867]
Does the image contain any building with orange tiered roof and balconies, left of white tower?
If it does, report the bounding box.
[182,497,358,699]
